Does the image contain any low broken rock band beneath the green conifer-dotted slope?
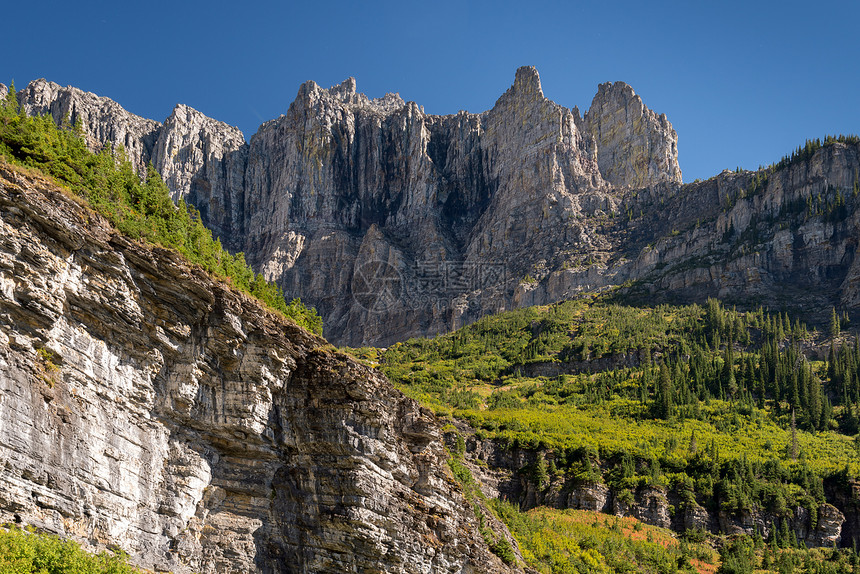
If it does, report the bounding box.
[456,434,848,548]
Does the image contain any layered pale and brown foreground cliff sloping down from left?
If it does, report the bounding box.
[0,166,507,573]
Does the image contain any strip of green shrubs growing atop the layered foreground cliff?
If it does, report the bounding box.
[0,85,322,334]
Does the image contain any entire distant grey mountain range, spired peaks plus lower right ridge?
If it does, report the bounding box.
[20,68,860,345]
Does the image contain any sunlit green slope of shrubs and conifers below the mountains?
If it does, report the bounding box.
[381,299,860,516]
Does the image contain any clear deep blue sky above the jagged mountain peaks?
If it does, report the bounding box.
[0,0,860,181]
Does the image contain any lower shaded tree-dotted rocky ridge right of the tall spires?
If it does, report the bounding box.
[630,143,860,321]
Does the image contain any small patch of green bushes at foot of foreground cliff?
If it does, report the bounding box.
[0,526,140,574]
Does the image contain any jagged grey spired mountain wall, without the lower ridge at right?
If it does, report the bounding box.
[11,68,680,344]
